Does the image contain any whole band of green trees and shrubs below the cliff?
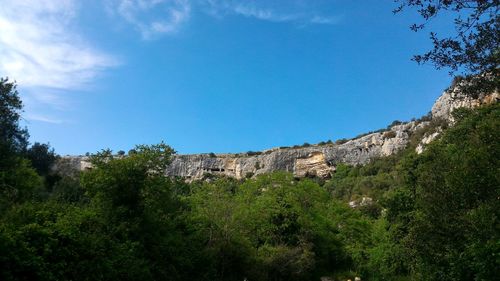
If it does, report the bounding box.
[0,80,500,281]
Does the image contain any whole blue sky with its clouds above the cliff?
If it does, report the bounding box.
[0,0,451,154]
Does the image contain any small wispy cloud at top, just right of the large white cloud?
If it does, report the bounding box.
[107,0,191,39]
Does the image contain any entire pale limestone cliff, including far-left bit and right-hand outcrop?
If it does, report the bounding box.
[56,87,498,181]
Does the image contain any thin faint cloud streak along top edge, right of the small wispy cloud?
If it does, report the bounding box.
[202,0,340,25]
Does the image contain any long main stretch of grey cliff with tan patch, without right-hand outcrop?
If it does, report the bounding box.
[166,122,418,180]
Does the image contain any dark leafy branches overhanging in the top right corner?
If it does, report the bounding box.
[394,0,500,95]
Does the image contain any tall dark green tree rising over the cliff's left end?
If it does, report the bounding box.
[81,143,201,280]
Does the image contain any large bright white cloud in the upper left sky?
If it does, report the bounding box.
[0,0,118,123]
